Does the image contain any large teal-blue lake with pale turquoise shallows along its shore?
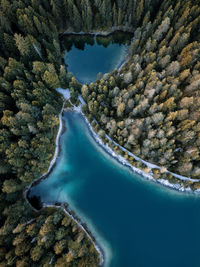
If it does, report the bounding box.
[30,112,200,267]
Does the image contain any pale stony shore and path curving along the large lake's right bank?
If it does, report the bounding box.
[57,88,200,193]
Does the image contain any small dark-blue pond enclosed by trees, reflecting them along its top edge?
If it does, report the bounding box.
[62,33,132,83]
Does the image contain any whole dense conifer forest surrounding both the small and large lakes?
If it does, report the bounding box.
[0,0,200,267]
